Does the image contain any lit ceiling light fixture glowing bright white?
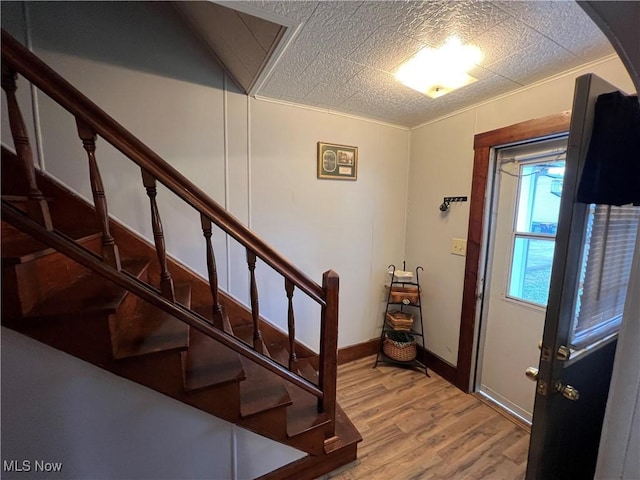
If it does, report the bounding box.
[396,37,482,98]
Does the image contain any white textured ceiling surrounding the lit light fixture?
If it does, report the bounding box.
[243,0,614,126]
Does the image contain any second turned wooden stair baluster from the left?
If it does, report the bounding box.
[76,117,121,271]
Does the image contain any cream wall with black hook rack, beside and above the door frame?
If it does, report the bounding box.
[406,57,634,365]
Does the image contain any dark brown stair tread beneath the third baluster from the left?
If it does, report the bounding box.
[112,283,191,359]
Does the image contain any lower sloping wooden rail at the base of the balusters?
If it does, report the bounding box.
[2,200,324,401]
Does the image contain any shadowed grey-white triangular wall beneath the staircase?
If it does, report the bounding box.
[1,328,304,480]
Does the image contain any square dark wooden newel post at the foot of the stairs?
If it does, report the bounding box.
[318,270,340,439]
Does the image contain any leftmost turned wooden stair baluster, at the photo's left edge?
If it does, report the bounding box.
[2,63,53,230]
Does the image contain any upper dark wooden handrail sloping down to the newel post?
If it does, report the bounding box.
[2,29,325,306]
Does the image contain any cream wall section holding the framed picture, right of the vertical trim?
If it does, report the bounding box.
[251,102,408,348]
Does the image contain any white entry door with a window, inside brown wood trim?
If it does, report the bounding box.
[477,136,567,422]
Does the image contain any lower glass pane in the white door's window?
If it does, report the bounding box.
[509,236,555,305]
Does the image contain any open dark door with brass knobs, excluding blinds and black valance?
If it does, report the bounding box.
[526,74,616,480]
